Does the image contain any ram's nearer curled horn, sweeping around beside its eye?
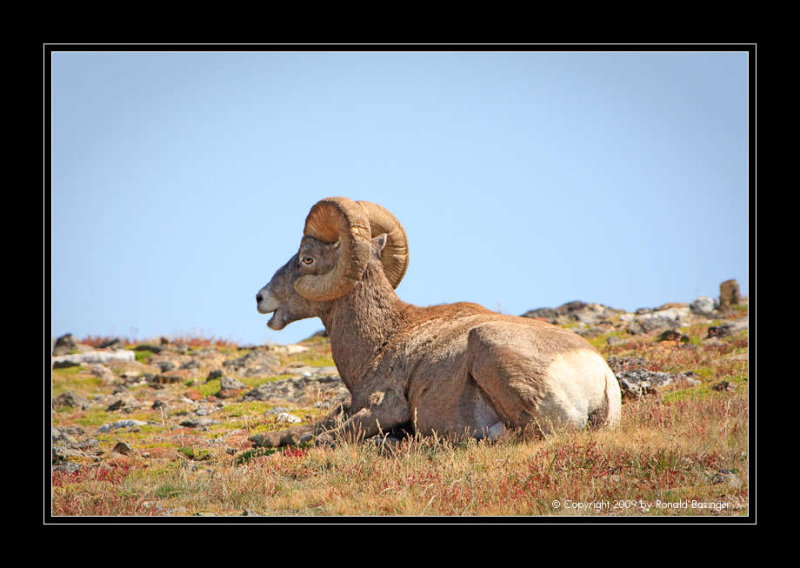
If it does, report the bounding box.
[294,197,371,302]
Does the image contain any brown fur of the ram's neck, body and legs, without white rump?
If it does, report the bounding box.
[251,239,616,445]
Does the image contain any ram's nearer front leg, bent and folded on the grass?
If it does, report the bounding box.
[315,390,410,445]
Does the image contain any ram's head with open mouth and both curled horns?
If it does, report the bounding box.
[256,197,408,330]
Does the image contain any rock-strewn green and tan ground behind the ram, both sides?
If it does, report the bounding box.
[51,281,749,514]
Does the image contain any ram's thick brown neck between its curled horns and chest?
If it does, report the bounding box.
[322,263,405,391]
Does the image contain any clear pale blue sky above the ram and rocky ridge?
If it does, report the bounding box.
[50,51,749,344]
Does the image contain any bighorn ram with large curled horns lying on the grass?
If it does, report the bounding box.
[250,197,621,446]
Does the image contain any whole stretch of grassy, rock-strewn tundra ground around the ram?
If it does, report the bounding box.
[48,282,751,519]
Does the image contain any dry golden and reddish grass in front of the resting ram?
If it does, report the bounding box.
[51,316,750,520]
